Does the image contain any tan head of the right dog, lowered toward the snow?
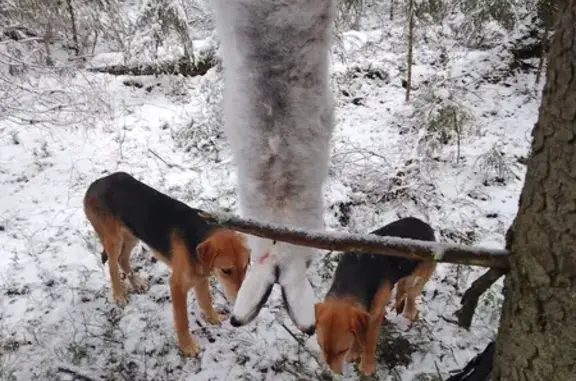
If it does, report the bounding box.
[314,300,370,373]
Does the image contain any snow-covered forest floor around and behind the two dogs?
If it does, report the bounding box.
[0,11,539,381]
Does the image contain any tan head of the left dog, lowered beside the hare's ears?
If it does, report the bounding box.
[196,229,250,302]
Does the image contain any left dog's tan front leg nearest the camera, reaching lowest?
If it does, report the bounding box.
[170,273,200,356]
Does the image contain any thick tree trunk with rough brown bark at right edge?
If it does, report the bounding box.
[494,0,576,381]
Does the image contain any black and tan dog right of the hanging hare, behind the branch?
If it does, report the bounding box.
[315,218,435,375]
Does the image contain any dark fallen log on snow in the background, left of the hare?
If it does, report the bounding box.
[87,57,217,77]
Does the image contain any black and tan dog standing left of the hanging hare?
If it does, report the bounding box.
[84,172,250,356]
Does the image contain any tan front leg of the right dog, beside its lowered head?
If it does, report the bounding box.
[360,283,392,376]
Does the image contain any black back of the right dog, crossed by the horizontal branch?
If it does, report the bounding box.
[327,217,435,310]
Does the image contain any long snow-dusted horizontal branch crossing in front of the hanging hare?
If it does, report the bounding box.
[200,212,508,270]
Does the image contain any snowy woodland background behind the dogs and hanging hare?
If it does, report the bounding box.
[0,0,555,381]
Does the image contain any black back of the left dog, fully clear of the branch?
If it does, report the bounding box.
[85,172,211,259]
